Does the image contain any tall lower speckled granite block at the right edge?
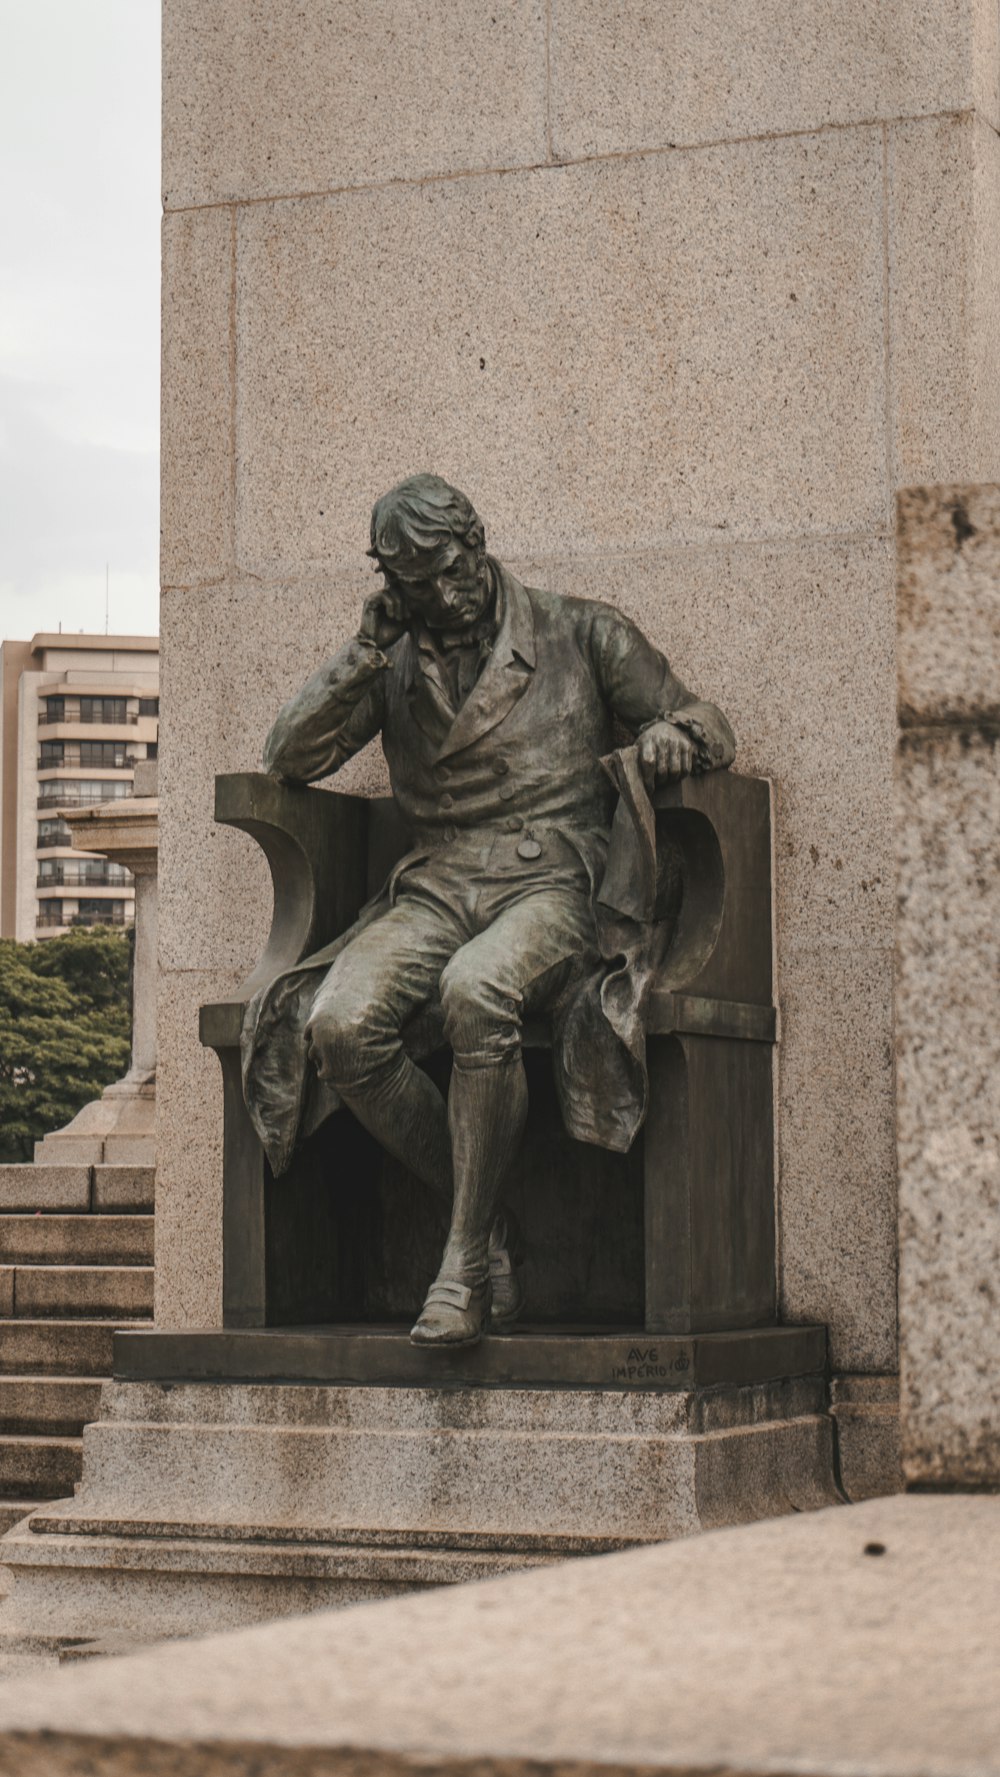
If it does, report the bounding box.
[897,721,1000,1486]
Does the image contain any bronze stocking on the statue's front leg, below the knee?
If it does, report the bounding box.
[440,1050,528,1276]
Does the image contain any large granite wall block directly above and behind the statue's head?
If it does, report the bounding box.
[236,130,886,578]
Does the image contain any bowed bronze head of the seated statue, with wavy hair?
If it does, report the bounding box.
[368,474,490,629]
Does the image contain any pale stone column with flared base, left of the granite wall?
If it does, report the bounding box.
[36,761,158,1166]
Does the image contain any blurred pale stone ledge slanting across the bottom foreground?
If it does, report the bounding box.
[0,1496,1000,1777]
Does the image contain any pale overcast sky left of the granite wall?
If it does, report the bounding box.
[0,0,160,640]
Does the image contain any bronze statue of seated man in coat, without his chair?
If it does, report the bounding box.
[253,474,735,1345]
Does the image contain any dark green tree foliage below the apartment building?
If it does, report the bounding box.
[0,926,131,1160]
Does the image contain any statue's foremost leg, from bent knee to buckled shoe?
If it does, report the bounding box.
[410,889,593,1345]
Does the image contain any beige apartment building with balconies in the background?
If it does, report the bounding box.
[0,634,160,940]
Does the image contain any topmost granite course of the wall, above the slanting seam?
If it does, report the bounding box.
[163,0,1000,210]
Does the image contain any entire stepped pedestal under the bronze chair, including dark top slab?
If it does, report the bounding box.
[0,1327,837,1644]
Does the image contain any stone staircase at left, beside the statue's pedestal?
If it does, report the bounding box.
[0,1166,155,1534]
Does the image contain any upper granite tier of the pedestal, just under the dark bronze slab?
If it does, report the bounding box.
[23,1383,835,1558]
